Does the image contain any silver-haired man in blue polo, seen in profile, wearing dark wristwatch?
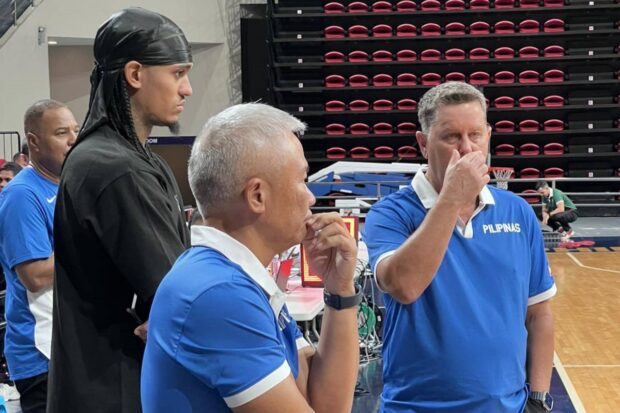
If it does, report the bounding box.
[141,104,361,413]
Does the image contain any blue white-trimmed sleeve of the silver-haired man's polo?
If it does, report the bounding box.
[176,285,291,409]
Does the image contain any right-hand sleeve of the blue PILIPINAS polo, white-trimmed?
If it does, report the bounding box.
[525,206,557,305]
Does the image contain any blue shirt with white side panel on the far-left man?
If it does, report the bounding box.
[0,167,58,380]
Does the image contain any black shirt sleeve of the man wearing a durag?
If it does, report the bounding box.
[93,172,185,301]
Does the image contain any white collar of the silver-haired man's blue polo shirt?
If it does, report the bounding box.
[191,225,286,318]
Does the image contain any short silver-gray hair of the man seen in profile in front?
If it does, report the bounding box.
[188,103,306,217]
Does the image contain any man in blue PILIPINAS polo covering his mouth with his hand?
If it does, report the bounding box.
[363,82,556,413]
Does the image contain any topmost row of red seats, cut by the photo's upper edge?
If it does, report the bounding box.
[323,0,564,14]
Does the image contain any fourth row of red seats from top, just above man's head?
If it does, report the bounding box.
[324,69,564,88]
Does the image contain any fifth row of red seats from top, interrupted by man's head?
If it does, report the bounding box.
[324,95,565,112]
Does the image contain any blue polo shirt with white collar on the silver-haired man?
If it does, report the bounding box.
[141,225,309,413]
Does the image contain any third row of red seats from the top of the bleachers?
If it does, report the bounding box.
[323,45,565,63]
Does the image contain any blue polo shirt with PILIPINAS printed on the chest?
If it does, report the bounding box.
[363,170,556,413]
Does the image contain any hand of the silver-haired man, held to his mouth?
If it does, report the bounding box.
[302,212,357,296]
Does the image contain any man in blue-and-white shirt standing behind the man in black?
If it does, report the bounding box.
[0,100,78,413]
